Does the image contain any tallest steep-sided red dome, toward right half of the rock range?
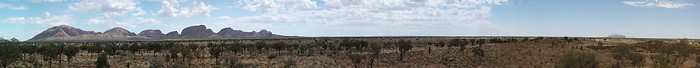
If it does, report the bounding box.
[180,25,215,38]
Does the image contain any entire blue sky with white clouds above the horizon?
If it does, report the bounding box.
[0,0,700,40]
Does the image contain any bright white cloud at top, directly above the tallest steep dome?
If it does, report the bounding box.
[157,0,217,17]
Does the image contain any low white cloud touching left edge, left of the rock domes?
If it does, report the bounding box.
[4,12,73,25]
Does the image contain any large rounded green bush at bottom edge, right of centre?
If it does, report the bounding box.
[556,52,599,68]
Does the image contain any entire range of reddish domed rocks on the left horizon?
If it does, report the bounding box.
[27,25,292,41]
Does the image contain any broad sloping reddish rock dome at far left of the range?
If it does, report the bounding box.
[29,25,99,40]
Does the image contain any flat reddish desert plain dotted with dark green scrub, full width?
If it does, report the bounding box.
[0,37,700,68]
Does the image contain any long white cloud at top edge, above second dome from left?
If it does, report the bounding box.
[68,0,145,17]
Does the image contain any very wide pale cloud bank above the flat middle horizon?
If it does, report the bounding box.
[227,0,508,26]
